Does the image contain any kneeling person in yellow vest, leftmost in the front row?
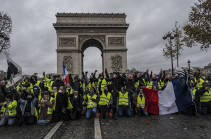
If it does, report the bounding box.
[0,93,17,126]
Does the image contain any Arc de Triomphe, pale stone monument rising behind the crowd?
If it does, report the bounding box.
[53,13,129,76]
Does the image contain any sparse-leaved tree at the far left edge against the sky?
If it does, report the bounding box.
[0,12,12,53]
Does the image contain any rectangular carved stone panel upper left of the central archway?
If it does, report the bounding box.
[59,37,76,47]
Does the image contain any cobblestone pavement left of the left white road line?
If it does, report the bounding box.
[0,123,55,139]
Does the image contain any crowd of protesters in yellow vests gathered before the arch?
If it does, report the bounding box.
[0,70,211,126]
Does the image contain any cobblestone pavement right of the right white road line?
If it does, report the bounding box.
[100,114,211,139]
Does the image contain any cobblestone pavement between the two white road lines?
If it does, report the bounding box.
[52,119,94,139]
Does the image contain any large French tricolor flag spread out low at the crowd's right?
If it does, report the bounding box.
[143,75,193,115]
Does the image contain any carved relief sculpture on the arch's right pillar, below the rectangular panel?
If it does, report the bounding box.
[111,55,122,72]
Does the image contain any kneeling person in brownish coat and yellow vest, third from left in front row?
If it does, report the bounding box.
[37,91,54,125]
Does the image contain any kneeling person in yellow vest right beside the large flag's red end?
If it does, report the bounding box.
[133,89,148,116]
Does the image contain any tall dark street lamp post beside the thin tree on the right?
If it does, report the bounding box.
[163,32,176,76]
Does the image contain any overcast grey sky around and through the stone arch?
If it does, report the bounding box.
[0,0,211,74]
